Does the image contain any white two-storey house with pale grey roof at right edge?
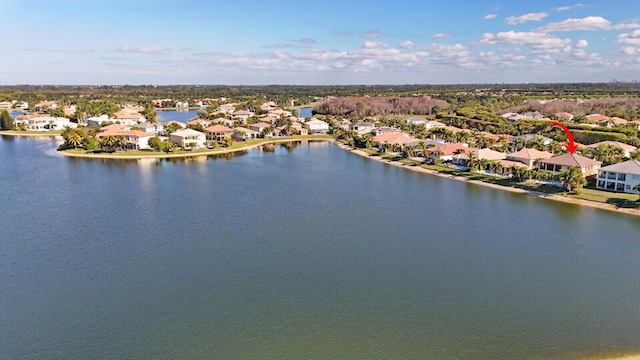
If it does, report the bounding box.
[596,160,640,194]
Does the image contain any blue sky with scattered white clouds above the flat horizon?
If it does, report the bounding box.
[0,0,640,85]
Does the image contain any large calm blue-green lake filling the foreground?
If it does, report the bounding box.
[0,137,640,359]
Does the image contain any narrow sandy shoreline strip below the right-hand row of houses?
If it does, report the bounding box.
[334,141,640,218]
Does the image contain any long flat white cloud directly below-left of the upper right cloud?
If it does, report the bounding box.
[478,31,571,51]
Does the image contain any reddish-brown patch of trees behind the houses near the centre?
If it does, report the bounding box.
[313,96,449,116]
